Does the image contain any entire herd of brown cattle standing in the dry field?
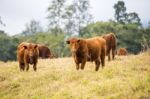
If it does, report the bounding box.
[17,33,127,71]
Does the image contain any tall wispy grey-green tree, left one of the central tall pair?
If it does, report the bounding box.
[47,0,66,35]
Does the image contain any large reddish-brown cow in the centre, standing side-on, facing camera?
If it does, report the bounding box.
[66,37,106,71]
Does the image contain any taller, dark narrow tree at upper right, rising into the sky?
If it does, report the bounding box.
[114,1,127,23]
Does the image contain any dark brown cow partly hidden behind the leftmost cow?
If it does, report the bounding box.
[38,44,53,59]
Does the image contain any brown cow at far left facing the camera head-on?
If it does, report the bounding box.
[17,42,39,71]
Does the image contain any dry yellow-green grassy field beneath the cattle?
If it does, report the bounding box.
[0,52,150,99]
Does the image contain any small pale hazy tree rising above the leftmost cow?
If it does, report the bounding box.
[22,20,43,35]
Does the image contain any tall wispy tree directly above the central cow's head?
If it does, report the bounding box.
[73,0,92,36]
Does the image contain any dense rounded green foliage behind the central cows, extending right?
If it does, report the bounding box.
[81,21,145,54]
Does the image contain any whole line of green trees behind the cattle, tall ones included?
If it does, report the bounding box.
[0,0,150,61]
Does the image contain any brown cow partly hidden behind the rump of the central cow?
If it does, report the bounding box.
[102,33,116,61]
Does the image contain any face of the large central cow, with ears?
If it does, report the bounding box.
[66,38,80,53]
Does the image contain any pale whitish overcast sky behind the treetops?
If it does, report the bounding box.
[0,0,150,35]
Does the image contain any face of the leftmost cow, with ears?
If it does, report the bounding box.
[24,44,38,64]
